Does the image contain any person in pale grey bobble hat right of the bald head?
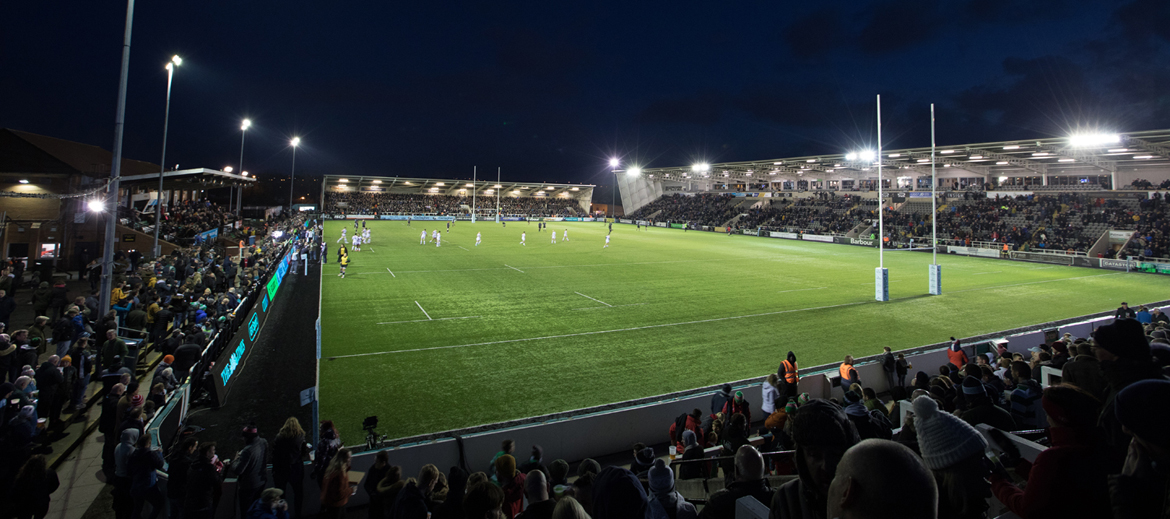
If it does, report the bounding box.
[914,396,991,518]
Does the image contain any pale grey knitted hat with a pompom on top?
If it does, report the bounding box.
[914,396,987,470]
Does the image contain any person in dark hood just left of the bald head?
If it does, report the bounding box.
[769,400,861,519]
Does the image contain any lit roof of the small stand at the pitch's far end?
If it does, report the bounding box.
[323,175,596,199]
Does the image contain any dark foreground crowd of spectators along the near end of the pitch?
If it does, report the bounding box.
[50,307,1170,519]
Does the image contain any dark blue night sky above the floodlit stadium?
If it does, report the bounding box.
[0,0,1170,194]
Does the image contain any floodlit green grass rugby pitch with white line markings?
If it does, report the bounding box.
[321,221,1170,443]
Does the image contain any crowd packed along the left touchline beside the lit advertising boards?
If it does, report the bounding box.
[0,210,315,517]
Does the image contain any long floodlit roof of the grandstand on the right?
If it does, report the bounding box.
[641,130,1170,184]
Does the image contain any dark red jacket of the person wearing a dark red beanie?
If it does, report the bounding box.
[991,427,1113,519]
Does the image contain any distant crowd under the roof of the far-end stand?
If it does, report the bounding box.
[324,192,585,216]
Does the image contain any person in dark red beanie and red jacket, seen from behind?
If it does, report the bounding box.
[991,386,1112,519]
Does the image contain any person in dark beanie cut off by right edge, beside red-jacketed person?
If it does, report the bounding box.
[1109,379,1170,519]
